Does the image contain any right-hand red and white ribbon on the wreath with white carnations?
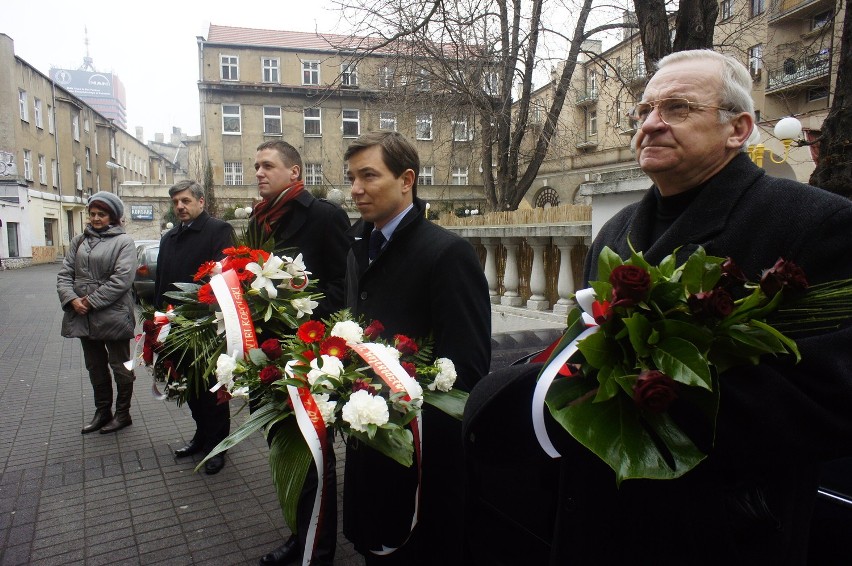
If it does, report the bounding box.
[351,342,423,555]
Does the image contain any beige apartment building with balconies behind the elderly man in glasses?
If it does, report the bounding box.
[527,0,845,221]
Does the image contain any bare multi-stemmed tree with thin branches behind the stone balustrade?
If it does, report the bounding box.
[338,0,623,210]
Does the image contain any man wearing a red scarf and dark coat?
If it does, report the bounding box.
[248,140,350,566]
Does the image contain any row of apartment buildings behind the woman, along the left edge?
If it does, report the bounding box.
[0,33,174,267]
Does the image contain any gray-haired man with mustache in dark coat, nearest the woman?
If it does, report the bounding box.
[154,180,234,474]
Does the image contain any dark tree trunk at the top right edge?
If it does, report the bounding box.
[810,0,852,198]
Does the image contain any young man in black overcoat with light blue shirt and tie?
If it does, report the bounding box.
[343,131,491,566]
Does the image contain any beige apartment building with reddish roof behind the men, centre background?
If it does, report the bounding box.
[197,25,484,215]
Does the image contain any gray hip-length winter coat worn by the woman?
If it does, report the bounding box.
[56,226,136,340]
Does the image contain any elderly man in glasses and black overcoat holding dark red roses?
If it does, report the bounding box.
[465,51,852,565]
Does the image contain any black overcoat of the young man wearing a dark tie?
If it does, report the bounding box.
[343,199,491,564]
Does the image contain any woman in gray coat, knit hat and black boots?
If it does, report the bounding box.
[56,191,136,434]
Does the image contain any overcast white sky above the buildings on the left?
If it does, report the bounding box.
[0,0,346,141]
